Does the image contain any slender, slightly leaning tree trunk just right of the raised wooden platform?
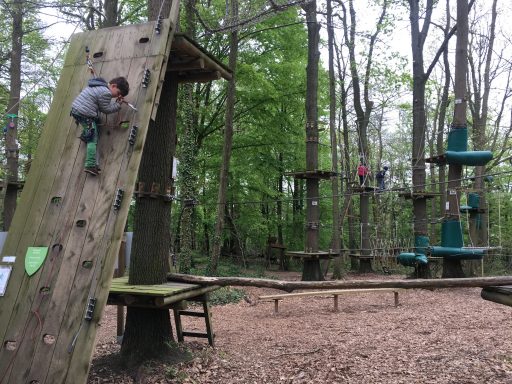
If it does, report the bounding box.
[206,0,238,276]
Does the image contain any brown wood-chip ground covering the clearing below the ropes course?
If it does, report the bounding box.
[88,273,512,384]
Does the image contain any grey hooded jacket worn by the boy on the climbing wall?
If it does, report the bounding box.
[71,77,121,119]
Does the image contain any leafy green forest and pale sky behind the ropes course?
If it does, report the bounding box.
[0,0,512,273]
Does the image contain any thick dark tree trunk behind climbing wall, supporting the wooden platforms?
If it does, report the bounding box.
[121,2,178,366]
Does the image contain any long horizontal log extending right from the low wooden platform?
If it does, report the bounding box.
[167,273,512,292]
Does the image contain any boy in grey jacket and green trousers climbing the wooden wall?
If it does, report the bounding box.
[71,77,130,176]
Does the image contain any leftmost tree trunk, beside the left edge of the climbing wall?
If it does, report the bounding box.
[3,0,23,231]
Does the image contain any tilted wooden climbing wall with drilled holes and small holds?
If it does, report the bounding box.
[0,6,179,384]
